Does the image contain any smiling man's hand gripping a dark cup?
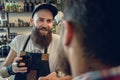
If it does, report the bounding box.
[12,57,27,73]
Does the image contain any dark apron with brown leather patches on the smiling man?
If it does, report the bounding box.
[14,36,50,80]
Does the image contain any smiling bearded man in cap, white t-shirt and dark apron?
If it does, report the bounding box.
[1,4,59,80]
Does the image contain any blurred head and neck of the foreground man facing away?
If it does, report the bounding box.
[59,0,120,77]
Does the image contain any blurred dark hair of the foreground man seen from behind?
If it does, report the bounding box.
[64,0,120,67]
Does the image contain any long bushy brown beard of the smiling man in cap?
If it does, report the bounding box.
[31,26,52,48]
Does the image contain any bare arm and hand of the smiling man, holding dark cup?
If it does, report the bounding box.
[0,49,27,78]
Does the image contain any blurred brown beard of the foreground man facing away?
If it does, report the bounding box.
[58,41,71,75]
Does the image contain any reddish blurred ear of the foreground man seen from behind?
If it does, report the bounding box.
[65,21,74,46]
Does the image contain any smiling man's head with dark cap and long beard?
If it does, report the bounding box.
[31,4,58,48]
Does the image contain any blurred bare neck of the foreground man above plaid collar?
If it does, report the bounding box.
[69,48,110,77]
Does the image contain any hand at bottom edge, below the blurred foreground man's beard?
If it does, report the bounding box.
[38,72,72,80]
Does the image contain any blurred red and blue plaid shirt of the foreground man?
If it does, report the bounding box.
[73,67,120,80]
